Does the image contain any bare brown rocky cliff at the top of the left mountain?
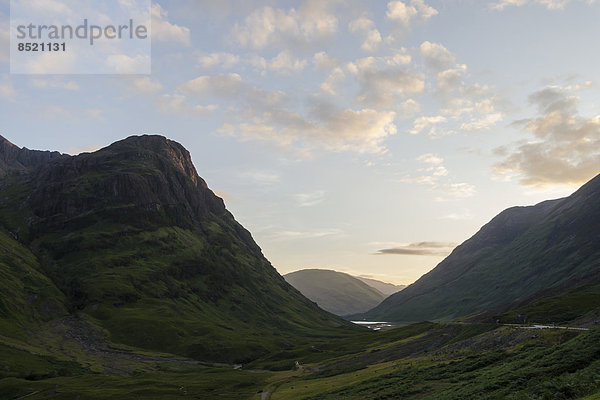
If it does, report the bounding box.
[30,136,227,233]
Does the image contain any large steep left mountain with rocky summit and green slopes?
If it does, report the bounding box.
[0,135,356,362]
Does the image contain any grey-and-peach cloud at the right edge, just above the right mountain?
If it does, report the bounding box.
[495,86,600,187]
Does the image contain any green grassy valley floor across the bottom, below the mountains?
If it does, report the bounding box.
[0,320,600,400]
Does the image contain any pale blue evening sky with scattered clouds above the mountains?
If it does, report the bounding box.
[0,0,600,284]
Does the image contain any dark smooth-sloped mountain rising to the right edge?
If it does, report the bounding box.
[361,175,600,321]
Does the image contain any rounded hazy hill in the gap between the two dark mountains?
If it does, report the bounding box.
[283,269,386,315]
